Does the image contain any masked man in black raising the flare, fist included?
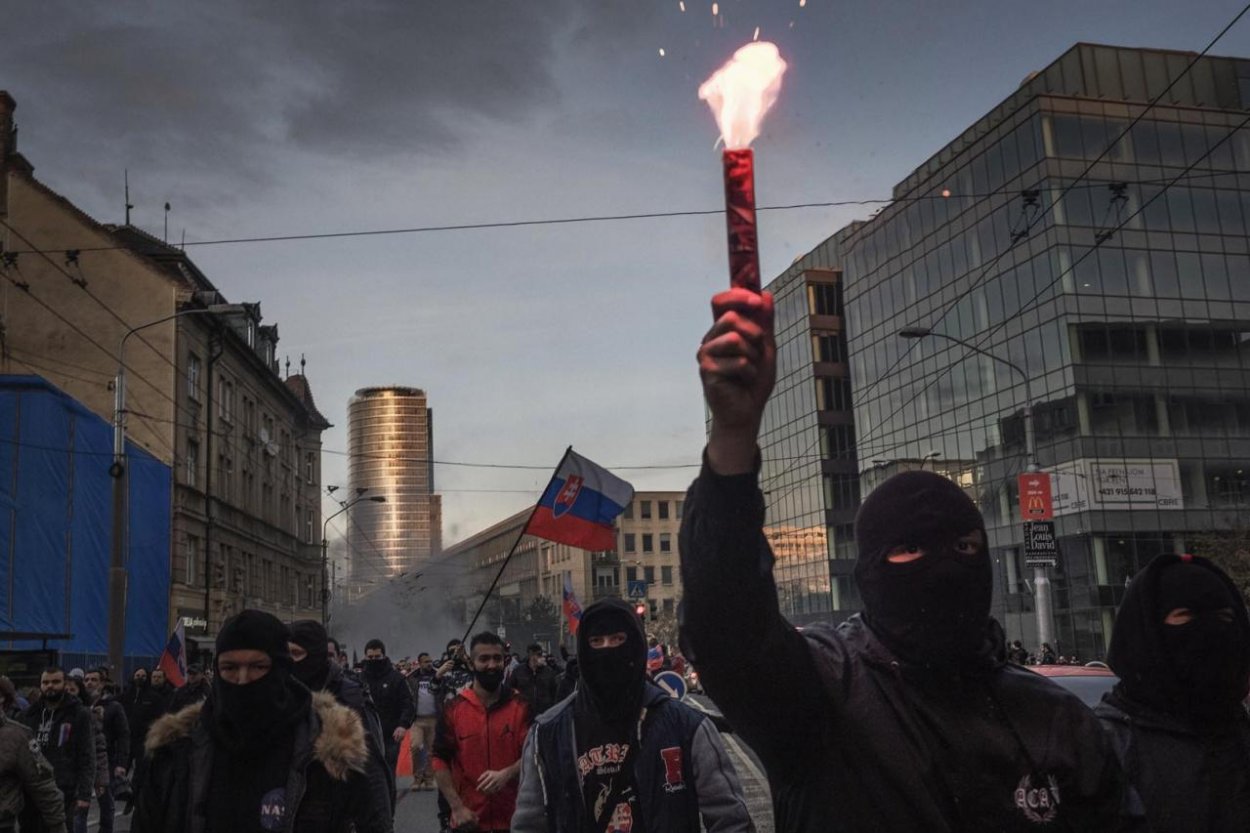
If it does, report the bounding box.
[680,289,1141,833]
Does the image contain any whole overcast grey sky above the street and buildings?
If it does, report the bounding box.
[0,0,1250,543]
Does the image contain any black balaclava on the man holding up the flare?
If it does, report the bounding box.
[855,472,994,667]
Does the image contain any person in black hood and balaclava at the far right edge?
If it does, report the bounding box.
[1095,555,1250,833]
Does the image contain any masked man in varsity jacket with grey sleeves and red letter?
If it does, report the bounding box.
[511,599,755,833]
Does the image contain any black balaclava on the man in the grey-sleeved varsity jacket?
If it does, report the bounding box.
[578,599,646,723]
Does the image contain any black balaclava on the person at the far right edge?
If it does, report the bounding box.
[1108,554,1250,724]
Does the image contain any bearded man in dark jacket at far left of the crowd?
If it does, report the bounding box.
[21,665,95,827]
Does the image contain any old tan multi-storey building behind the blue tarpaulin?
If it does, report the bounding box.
[0,93,329,644]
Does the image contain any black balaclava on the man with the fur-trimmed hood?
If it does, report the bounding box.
[208,610,307,752]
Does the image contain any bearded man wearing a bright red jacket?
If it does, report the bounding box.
[433,632,530,833]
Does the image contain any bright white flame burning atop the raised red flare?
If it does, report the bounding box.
[699,40,785,150]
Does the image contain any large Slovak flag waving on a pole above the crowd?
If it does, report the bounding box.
[525,449,634,552]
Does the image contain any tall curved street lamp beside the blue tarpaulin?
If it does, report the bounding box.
[109,304,248,674]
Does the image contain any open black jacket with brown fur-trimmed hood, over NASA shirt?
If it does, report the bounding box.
[130,693,391,833]
